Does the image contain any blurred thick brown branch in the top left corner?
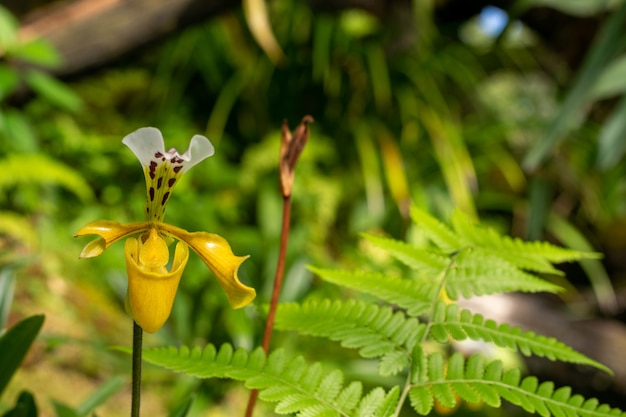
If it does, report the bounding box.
[14,0,240,75]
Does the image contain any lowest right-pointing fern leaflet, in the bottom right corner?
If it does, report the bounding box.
[409,349,626,417]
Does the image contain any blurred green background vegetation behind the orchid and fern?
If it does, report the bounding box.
[0,0,626,415]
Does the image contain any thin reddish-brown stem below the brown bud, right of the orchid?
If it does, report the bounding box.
[245,194,291,417]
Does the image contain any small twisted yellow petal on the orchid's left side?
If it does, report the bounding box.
[74,220,150,258]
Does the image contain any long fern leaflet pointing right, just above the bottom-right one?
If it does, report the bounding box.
[430,301,613,375]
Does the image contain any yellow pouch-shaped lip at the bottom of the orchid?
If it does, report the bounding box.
[124,237,189,333]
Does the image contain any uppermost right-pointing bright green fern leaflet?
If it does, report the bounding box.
[451,211,599,275]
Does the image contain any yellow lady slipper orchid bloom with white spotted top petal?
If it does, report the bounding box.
[75,127,256,333]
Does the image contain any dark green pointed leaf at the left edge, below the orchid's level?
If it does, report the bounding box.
[0,315,44,395]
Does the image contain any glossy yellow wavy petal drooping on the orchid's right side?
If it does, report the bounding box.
[159,223,256,308]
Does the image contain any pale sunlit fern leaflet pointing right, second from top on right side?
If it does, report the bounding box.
[446,250,562,300]
